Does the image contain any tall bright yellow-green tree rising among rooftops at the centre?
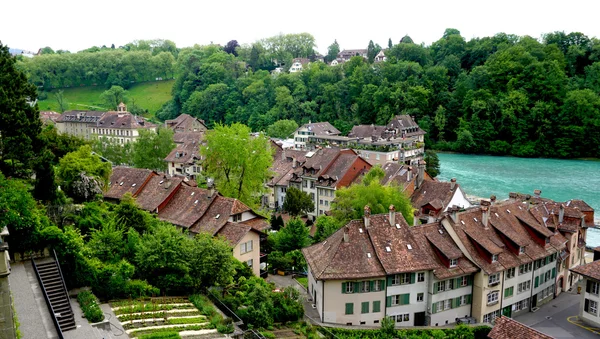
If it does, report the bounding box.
[201,123,273,206]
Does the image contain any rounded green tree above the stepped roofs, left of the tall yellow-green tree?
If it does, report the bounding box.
[133,127,175,171]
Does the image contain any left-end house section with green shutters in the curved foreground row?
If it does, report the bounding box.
[302,206,478,327]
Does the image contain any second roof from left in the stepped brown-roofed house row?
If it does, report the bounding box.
[136,174,183,212]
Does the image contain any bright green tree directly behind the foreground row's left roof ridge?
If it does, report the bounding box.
[331,166,413,225]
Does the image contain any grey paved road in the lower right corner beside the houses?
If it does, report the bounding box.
[515,292,600,339]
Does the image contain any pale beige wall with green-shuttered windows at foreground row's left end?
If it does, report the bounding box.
[323,277,385,326]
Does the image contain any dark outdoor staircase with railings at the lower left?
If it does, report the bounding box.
[35,260,76,332]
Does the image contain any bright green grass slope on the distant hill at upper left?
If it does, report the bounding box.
[38,80,175,117]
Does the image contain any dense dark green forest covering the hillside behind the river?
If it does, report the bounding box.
[16,29,600,158]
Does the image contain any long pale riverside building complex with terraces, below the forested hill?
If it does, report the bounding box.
[294,115,425,165]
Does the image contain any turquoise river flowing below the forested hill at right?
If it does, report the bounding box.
[438,153,600,247]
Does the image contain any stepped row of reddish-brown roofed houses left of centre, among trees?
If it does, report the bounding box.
[104,167,269,276]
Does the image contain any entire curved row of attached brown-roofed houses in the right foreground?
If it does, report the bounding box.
[303,191,594,326]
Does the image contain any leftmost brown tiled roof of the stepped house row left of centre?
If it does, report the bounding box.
[104,166,158,199]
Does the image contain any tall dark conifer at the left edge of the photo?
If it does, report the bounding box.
[0,43,45,177]
